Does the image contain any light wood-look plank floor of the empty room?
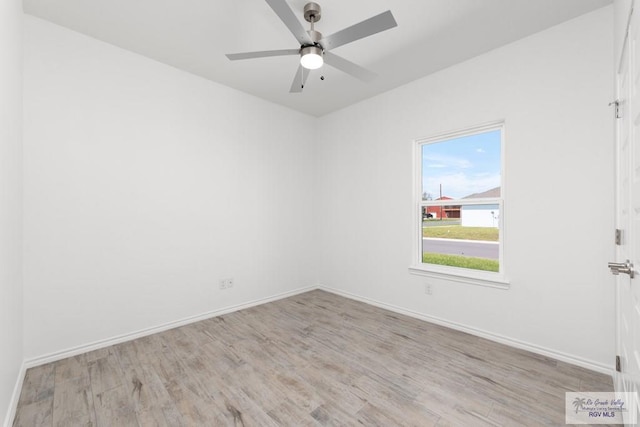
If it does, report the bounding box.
[14,291,613,427]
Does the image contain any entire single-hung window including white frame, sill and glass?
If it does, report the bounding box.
[411,123,507,287]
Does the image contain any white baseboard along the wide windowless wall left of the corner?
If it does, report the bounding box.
[23,286,318,369]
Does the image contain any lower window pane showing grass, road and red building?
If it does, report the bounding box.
[422,204,500,272]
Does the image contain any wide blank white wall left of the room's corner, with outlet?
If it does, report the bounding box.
[24,16,317,359]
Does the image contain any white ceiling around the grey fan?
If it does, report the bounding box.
[23,0,612,116]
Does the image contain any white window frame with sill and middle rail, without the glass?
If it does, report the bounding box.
[409,121,509,289]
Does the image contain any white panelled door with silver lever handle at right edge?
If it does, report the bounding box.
[612,2,640,419]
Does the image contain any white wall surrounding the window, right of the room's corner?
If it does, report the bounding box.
[317,7,614,368]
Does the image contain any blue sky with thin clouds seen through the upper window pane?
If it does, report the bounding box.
[422,130,501,200]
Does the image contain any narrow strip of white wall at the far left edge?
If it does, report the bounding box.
[0,0,22,420]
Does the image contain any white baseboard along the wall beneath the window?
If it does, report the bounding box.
[318,285,614,377]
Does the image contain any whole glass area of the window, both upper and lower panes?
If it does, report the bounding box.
[421,129,502,272]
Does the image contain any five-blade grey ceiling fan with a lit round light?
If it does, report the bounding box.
[227,0,398,92]
